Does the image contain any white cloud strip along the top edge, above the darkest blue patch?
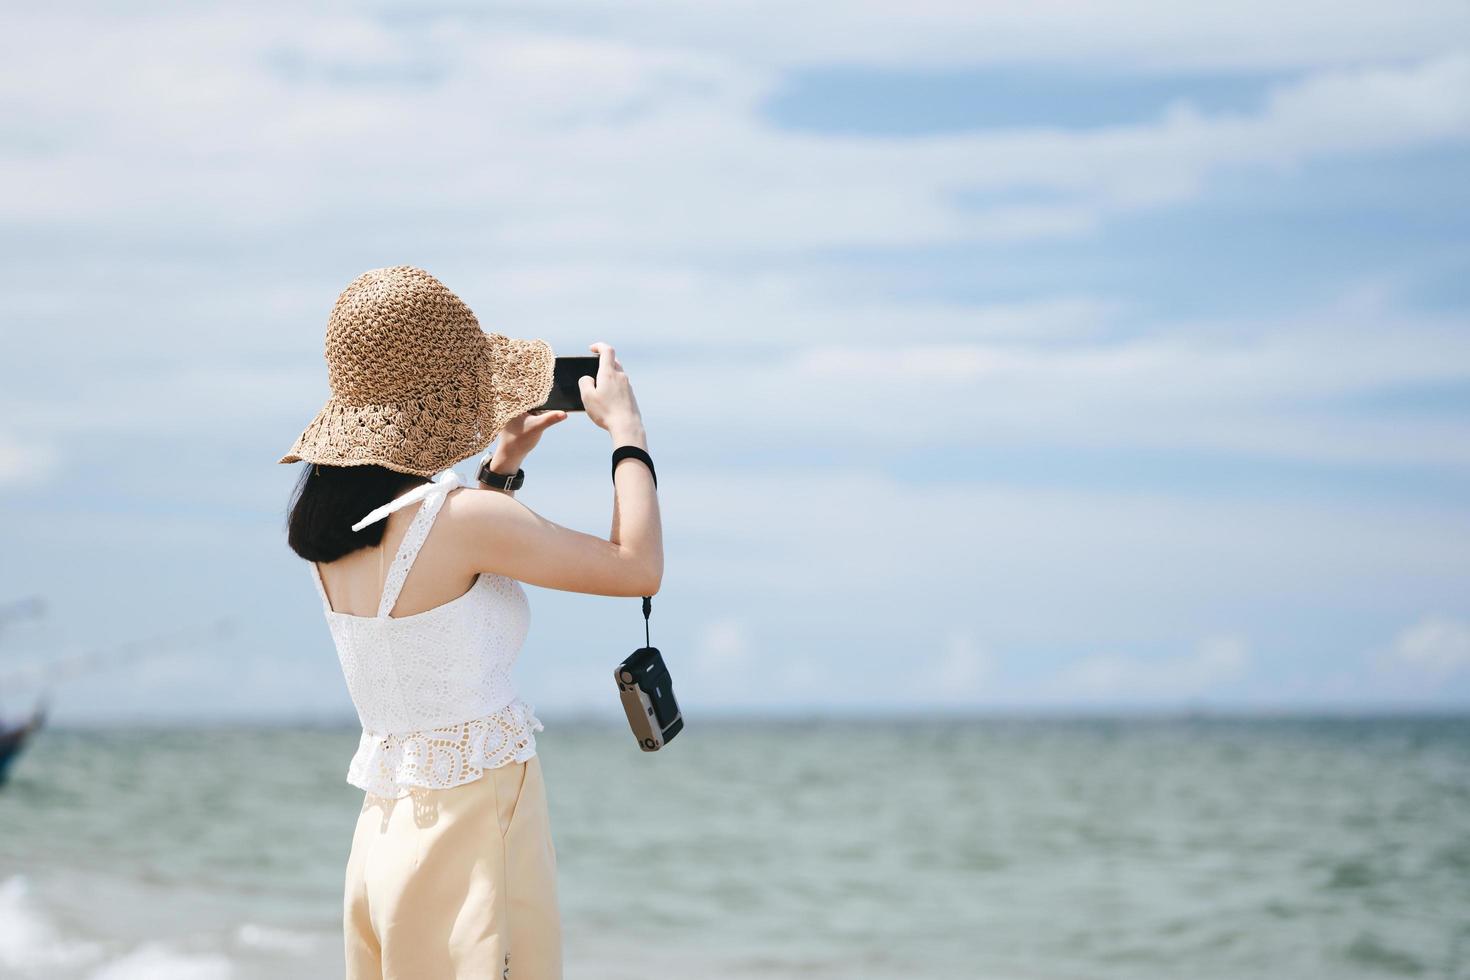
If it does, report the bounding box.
[522,0,1470,72]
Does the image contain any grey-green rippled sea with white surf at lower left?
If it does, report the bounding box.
[0,716,1470,980]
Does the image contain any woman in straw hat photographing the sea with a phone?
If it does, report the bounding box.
[281,266,663,980]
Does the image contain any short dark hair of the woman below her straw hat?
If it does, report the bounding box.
[287,463,429,561]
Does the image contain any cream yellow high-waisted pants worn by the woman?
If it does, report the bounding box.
[343,755,562,980]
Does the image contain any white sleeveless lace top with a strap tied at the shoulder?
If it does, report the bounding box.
[307,470,542,798]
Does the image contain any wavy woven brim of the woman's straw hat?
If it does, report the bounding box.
[278,334,556,476]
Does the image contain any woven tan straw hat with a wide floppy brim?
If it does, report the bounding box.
[279,266,556,476]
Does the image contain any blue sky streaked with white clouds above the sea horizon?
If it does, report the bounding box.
[0,0,1470,723]
